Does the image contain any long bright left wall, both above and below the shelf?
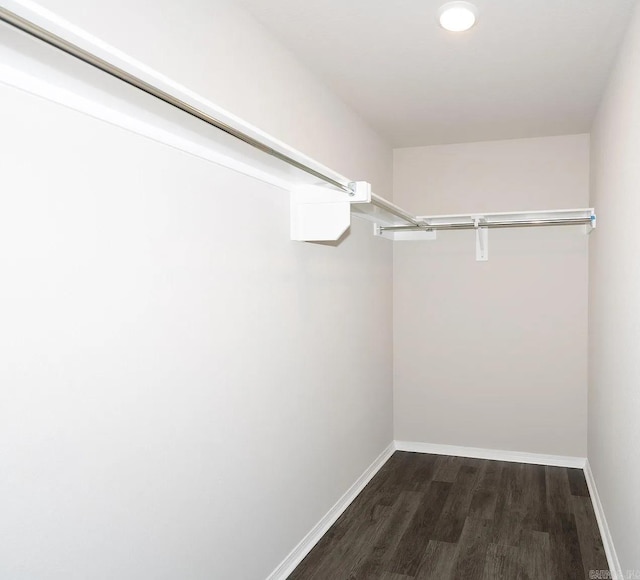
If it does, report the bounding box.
[0,1,392,580]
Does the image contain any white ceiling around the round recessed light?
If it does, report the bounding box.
[241,0,636,147]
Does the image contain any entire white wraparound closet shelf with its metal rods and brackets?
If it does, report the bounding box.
[0,0,595,260]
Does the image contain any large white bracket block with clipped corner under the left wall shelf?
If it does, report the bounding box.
[290,181,371,242]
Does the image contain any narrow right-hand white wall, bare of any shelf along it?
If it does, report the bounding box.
[589,0,640,570]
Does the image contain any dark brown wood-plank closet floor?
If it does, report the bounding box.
[289,451,608,580]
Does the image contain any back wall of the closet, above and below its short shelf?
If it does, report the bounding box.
[394,135,589,457]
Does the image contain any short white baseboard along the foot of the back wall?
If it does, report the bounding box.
[395,441,587,469]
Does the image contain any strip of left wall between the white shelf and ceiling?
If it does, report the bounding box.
[33,0,392,199]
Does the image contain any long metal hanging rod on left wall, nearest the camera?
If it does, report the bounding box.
[0,6,355,196]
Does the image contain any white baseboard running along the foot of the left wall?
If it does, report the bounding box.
[267,442,396,580]
